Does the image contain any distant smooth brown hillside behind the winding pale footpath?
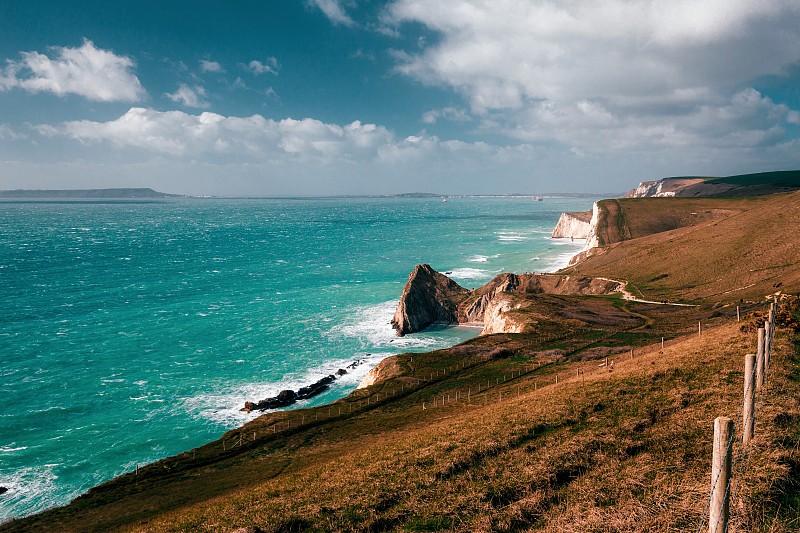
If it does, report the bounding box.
[564,193,800,304]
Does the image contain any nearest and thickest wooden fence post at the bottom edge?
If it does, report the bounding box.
[708,416,733,533]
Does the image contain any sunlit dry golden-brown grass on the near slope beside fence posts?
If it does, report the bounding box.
[15,316,784,532]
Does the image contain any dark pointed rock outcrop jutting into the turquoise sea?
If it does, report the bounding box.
[392,265,470,337]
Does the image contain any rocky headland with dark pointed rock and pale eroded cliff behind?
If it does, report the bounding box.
[392,265,622,335]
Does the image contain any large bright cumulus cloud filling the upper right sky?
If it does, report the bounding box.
[386,0,800,151]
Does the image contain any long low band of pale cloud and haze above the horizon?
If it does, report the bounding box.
[21,104,800,195]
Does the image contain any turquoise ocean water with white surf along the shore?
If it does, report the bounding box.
[0,198,592,521]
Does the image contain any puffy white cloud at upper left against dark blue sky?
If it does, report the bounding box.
[0,39,145,102]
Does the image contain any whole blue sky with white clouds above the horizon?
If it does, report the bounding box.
[0,0,800,196]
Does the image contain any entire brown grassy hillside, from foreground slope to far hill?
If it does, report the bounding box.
[6,189,800,532]
